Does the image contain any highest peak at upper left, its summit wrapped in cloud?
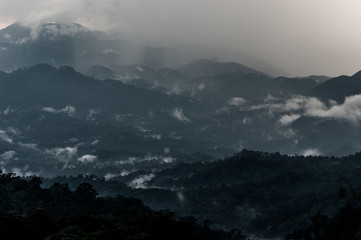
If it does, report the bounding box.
[0,23,137,71]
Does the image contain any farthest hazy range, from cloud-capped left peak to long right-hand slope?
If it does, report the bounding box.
[0,23,282,76]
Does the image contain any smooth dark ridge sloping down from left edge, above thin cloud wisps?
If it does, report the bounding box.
[0,64,197,113]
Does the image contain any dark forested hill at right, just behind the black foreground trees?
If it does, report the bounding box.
[43,150,361,238]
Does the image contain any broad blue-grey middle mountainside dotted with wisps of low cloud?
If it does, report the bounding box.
[0,64,359,176]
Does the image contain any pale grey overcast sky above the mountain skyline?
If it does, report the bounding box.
[0,0,361,76]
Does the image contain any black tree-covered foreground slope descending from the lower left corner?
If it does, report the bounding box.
[0,173,245,240]
